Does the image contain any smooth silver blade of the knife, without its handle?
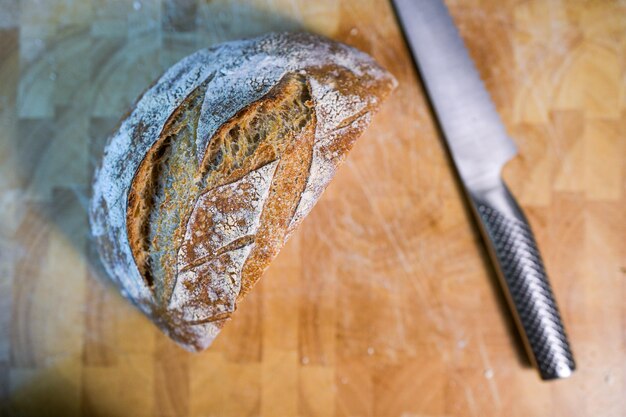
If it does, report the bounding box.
[394,0,517,189]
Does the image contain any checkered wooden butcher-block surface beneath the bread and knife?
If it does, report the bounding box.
[0,0,626,417]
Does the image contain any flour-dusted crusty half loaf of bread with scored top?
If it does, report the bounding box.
[89,33,396,351]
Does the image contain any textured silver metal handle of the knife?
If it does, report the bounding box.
[470,181,576,380]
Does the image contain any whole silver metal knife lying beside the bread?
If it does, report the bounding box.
[392,0,576,380]
